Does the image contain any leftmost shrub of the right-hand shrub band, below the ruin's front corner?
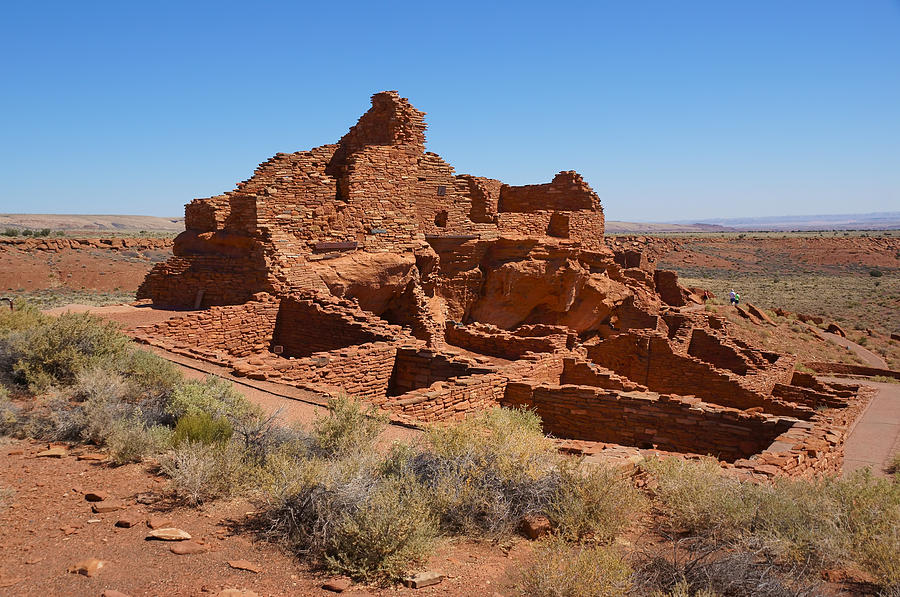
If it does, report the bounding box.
[641,457,759,540]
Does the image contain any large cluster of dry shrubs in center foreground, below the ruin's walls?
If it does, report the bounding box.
[267,398,639,580]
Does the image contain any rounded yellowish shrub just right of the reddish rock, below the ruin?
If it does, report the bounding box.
[546,459,643,541]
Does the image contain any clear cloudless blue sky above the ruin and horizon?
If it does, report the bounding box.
[0,0,900,221]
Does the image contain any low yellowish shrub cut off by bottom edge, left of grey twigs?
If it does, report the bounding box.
[517,538,632,597]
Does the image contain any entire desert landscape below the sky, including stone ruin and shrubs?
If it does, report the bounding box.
[0,91,900,597]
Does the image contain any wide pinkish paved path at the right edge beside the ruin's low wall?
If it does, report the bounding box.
[844,382,900,476]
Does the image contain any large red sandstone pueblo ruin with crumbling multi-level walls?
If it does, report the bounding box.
[134,91,865,477]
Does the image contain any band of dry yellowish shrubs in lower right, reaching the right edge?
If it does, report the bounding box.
[644,459,900,587]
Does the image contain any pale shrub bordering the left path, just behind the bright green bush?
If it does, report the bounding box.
[167,375,260,421]
